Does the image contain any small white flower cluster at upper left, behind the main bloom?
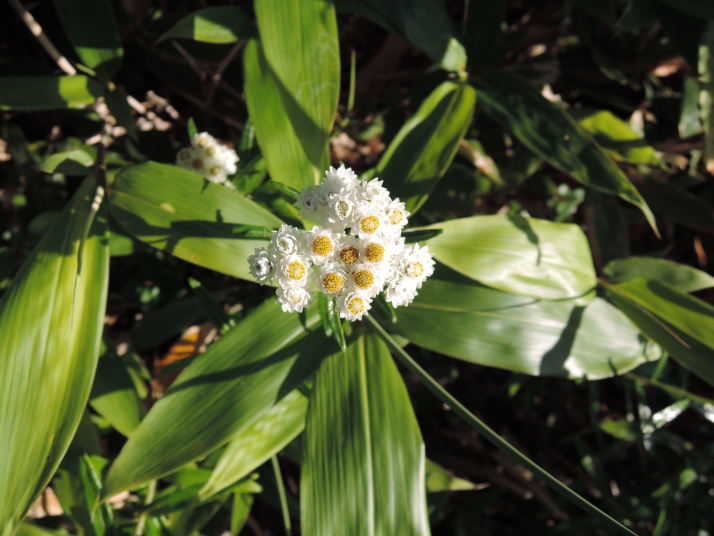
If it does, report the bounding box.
[176,132,238,186]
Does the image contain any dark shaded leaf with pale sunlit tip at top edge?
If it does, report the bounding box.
[337,0,466,71]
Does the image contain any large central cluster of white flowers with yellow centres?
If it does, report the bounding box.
[248,166,434,321]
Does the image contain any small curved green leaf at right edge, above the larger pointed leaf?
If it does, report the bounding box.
[603,257,714,292]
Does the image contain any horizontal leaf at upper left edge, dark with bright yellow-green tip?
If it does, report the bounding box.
[0,75,104,110]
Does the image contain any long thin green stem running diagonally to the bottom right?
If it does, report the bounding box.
[366,316,637,536]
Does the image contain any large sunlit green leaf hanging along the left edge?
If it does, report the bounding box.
[0,179,109,534]
